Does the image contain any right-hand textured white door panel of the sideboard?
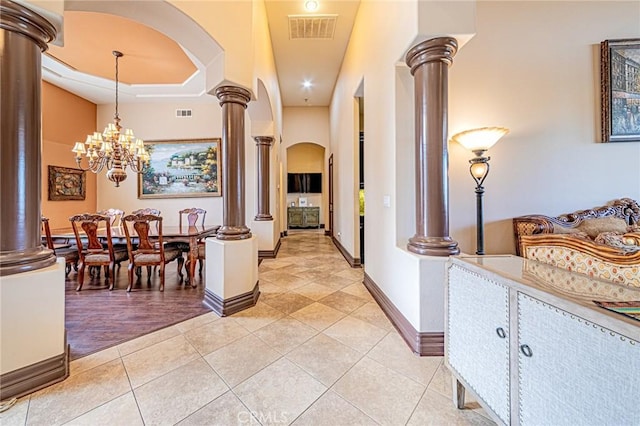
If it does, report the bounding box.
[518,293,640,426]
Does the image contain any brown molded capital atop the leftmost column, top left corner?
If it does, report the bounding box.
[0,0,57,52]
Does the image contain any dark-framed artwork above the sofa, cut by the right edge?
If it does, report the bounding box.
[600,39,640,142]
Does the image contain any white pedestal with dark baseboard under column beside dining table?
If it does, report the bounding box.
[204,236,259,316]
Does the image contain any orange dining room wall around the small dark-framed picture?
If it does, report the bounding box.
[41,82,96,229]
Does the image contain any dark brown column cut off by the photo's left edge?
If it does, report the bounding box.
[0,0,56,276]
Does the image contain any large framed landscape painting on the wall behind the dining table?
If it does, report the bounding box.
[138,138,222,198]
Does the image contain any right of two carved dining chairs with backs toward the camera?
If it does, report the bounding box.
[122,212,184,292]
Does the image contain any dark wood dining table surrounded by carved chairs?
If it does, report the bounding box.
[51,225,220,286]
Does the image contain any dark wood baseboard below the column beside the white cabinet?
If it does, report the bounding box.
[364,272,444,356]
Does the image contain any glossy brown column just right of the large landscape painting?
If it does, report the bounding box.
[216,86,251,240]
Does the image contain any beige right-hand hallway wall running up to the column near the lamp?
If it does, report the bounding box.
[328,1,424,322]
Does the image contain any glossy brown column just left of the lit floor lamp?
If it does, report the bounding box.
[406,37,460,256]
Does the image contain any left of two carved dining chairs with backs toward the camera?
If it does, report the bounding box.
[69,213,127,291]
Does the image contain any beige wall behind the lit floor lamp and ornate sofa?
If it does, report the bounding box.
[449,1,640,254]
